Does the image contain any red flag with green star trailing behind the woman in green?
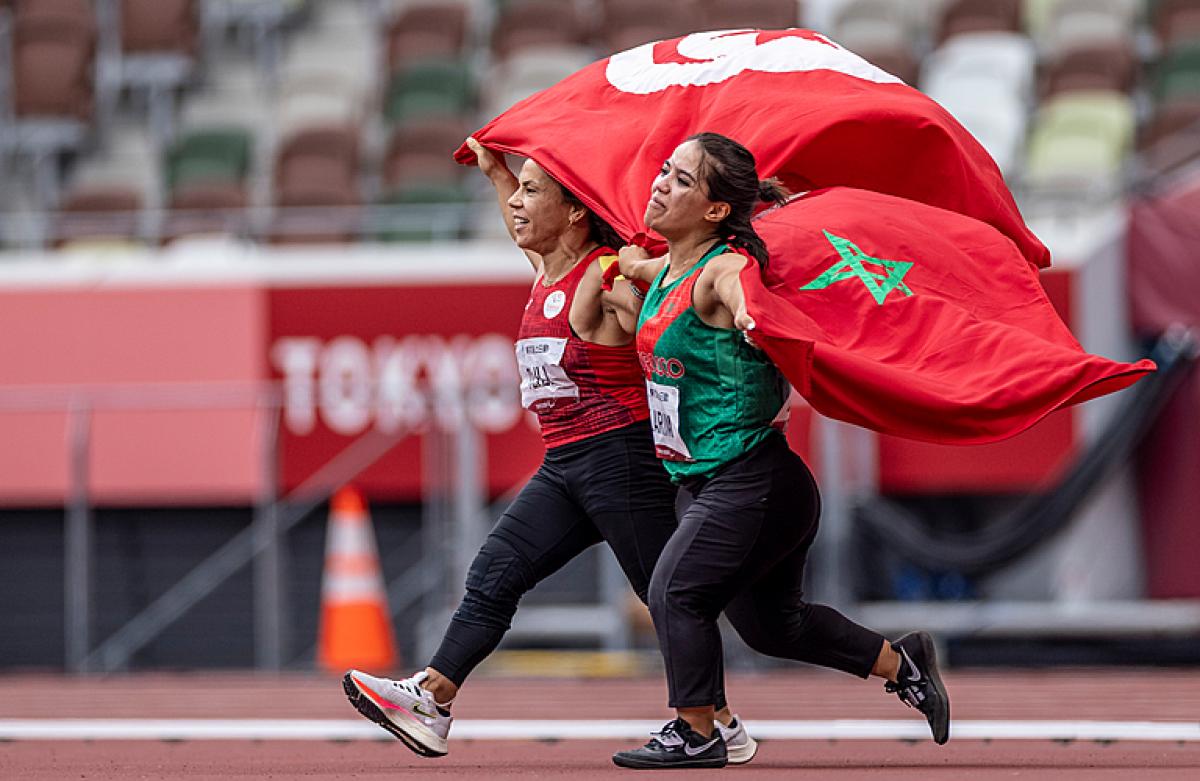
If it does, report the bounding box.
[742,187,1154,444]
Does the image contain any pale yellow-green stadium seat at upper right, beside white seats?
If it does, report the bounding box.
[1025,91,1135,187]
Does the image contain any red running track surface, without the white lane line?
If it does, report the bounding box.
[0,671,1200,781]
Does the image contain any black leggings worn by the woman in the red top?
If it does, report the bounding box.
[430,422,725,708]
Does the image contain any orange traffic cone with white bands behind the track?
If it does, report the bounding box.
[317,486,398,674]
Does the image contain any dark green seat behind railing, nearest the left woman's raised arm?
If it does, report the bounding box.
[372,182,472,242]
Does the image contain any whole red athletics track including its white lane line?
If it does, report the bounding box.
[0,669,1200,781]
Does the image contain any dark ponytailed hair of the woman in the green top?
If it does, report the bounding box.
[688,133,788,266]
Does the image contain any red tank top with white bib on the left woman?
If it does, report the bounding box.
[517,247,649,447]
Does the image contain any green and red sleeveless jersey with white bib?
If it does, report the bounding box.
[637,245,791,481]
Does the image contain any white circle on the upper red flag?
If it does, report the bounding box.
[605,30,904,95]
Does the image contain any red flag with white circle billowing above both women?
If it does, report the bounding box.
[456,29,1050,266]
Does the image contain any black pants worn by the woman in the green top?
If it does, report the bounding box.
[649,434,883,708]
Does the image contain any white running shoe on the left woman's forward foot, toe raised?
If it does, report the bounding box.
[342,669,454,757]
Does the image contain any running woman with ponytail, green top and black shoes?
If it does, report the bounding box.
[613,133,949,769]
